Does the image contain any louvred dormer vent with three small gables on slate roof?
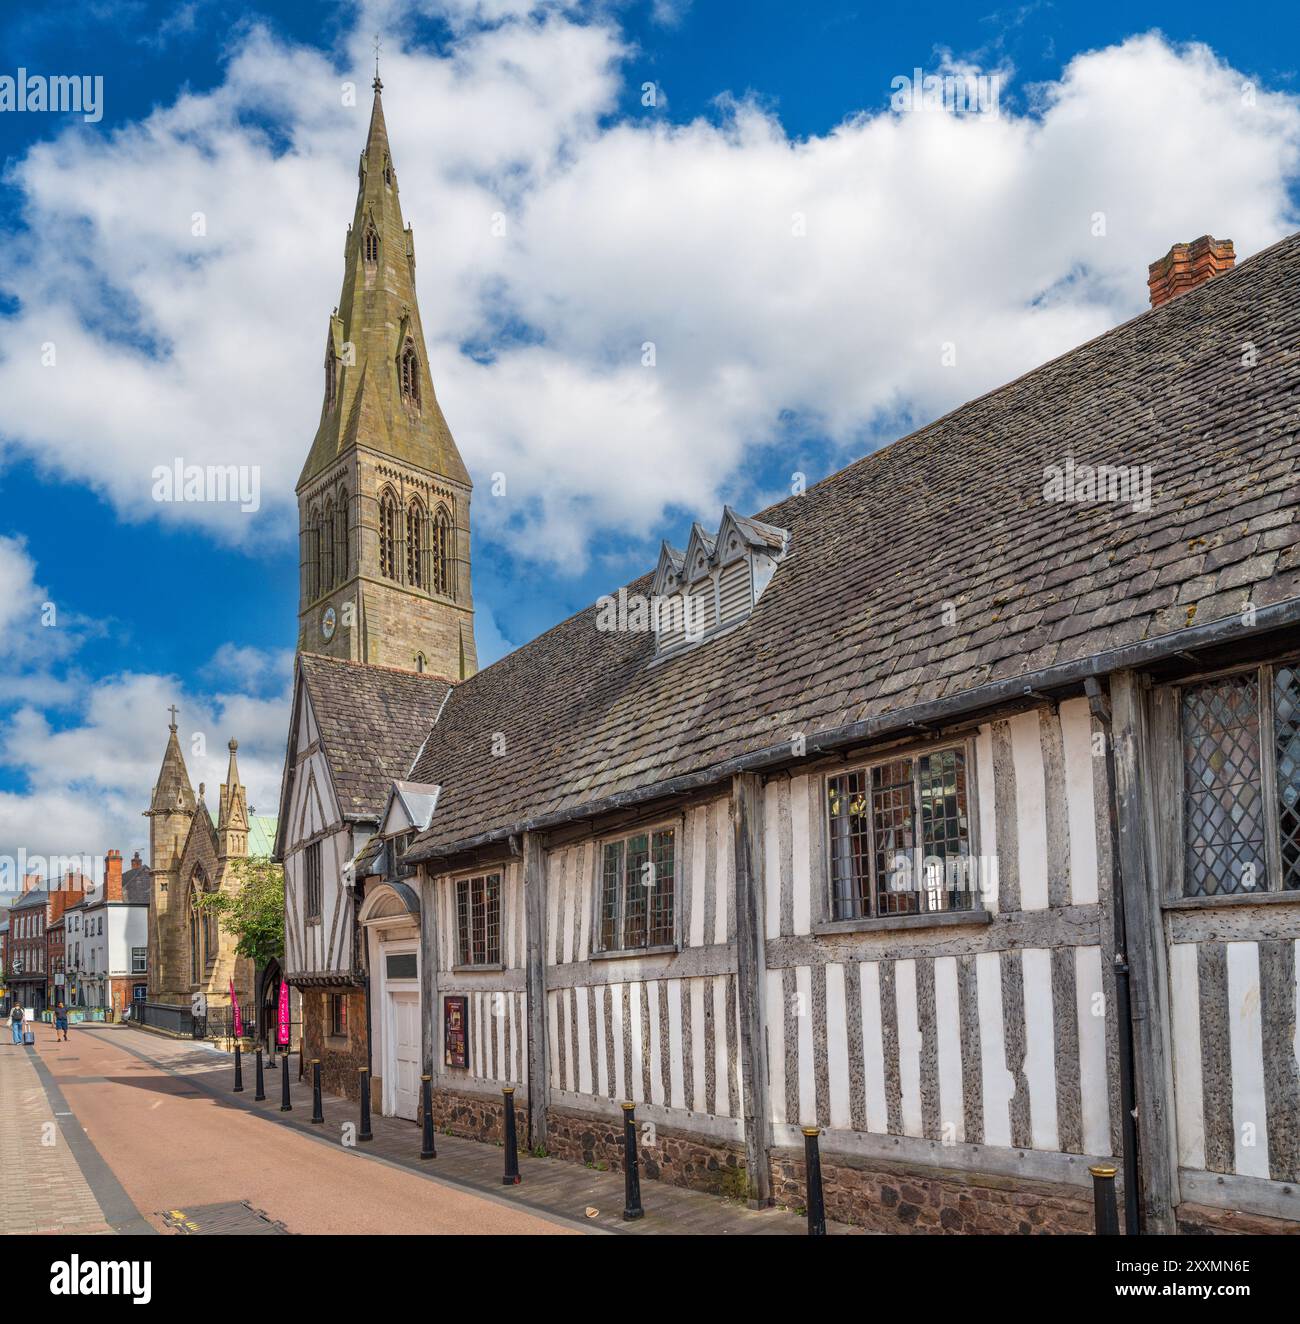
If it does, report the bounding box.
[653,506,790,657]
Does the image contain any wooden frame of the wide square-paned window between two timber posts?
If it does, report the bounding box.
[813,730,992,932]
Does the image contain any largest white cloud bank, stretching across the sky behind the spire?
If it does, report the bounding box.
[0,20,1300,565]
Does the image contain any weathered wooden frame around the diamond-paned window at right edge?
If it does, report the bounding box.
[1149,650,1300,910]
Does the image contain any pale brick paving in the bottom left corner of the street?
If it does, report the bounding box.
[0,1026,111,1235]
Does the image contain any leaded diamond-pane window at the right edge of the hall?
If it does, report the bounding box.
[1180,662,1300,896]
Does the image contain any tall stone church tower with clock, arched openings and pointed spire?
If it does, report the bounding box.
[297,75,478,679]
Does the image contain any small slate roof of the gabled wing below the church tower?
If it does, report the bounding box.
[298,653,451,822]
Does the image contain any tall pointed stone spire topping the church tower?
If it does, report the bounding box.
[298,66,469,490]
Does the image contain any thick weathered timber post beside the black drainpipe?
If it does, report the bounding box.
[1109,671,1178,1233]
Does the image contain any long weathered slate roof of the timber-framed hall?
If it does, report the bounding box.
[409,236,1300,855]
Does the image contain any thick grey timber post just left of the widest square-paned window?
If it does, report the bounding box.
[731,773,772,1207]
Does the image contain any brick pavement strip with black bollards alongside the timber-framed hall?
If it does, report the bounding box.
[106,1029,860,1237]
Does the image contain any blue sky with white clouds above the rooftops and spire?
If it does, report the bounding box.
[0,0,1300,879]
